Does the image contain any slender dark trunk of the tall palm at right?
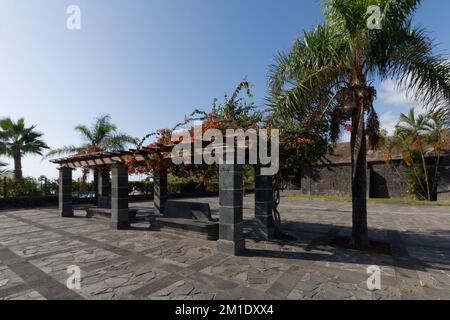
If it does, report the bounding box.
[351,110,369,249]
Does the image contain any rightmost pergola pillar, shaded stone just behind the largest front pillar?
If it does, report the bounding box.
[255,167,274,240]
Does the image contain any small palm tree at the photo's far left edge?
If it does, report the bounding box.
[0,118,48,179]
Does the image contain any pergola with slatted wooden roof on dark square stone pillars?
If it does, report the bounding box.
[51,145,274,255]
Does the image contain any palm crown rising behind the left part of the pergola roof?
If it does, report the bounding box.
[45,115,134,158]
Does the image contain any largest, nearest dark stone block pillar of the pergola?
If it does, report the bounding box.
[217,164,245,255]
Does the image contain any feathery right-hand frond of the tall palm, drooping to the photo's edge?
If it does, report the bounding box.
[367,21,450,107]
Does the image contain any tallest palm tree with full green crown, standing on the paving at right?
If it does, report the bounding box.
[269,0,450,248]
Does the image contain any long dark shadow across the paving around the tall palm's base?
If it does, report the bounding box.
[244,219,450,272]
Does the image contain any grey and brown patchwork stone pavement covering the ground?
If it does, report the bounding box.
[0,197,450,300]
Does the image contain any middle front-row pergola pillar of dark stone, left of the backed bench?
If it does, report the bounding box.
[111,163,130,230]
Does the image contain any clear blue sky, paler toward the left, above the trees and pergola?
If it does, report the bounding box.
[0,0,450,177]
